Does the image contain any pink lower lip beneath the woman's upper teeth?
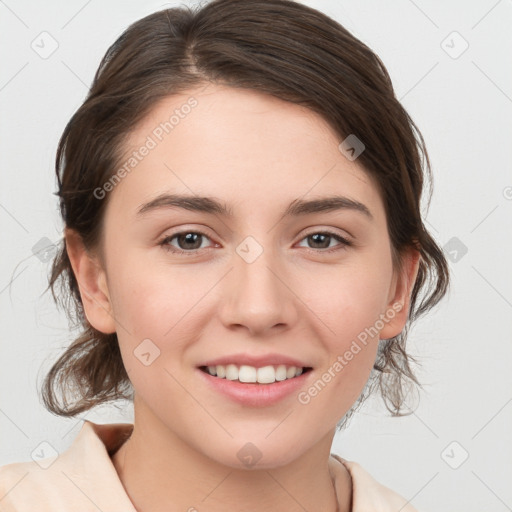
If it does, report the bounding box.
[197,368,312,407]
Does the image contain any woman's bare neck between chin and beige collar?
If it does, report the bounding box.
[112,400,351,512]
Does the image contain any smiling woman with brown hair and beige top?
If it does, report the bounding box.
[0,0,448,512]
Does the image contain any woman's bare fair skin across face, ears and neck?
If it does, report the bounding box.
[66,84,419,511]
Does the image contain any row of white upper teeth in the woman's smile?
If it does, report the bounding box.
[207,364,303,384]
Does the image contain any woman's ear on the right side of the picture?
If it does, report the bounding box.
[380,247,421,339]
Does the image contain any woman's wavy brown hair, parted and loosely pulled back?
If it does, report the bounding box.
[42,0,449,426]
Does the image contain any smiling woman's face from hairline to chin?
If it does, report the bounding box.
[71,85,416,467]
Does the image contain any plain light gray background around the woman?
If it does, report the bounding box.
[0,0,512,512]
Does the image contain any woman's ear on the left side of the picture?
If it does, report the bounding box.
[64,228,116,334]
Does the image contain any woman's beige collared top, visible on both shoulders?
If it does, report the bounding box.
[0,420,417,512]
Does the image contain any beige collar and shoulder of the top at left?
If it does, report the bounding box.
[0,421,134,512]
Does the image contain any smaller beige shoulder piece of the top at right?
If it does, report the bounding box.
[331,454,418,512]
